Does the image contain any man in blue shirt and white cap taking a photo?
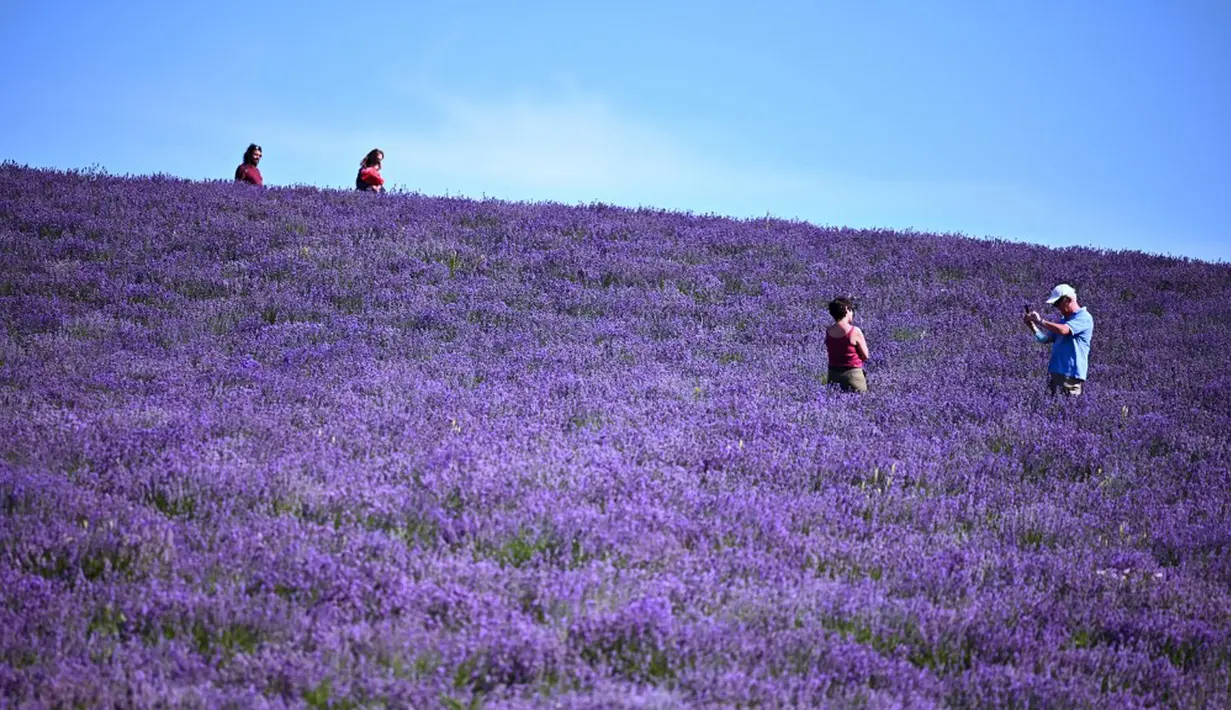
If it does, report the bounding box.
[1025,283,1094,396]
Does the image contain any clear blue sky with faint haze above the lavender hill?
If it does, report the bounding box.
[0,0,1231,261]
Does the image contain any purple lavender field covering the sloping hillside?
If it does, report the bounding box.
[0,164,1231,709]
